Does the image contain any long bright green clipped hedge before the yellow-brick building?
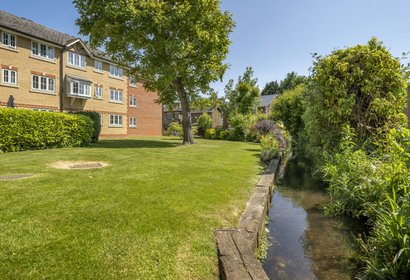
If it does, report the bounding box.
[0,108,94,152]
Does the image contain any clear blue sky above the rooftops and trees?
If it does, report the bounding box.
[0,0,410,96]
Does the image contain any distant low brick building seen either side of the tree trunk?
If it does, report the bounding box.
[163,106,223,130]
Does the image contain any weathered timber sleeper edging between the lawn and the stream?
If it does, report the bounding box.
[215,159,279,280]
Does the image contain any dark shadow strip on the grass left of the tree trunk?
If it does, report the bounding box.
[88,139,181,149]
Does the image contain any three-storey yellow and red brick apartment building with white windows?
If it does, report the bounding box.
[0,11,162,137]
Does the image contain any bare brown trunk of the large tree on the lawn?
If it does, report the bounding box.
[174,78,195,144]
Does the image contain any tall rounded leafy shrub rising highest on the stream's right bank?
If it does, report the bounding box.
[303,38,407,160]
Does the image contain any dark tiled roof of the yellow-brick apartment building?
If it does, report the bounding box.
[0,10,112,61]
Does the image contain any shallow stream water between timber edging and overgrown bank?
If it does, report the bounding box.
[263,162,364,280]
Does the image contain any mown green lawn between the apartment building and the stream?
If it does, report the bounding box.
[0,138,261,279]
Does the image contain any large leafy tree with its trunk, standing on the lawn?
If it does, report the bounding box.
[73,0,234,143]
